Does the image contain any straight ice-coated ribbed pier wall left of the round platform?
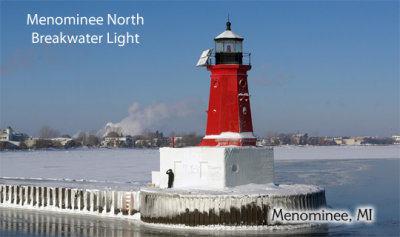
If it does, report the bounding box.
[0,184,139,216]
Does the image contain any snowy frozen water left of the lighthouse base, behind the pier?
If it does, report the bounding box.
[0,149,159,189]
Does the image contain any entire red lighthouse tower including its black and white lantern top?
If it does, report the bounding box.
[198,21,256,146]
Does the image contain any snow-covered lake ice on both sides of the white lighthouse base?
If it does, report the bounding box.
[0,145,400,189]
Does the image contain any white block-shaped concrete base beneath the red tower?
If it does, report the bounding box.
[152,146,274,190]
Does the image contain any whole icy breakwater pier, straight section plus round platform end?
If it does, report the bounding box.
[0,184,326,226]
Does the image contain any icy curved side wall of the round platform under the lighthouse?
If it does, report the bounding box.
[140,190,326,226]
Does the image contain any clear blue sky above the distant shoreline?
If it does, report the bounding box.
[0,1,400,136]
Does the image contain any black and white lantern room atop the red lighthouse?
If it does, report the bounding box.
[214,21,243,65]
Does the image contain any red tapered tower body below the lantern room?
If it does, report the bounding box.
[199,64,256,146]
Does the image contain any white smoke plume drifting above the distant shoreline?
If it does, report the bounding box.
[99,100,193,136]
